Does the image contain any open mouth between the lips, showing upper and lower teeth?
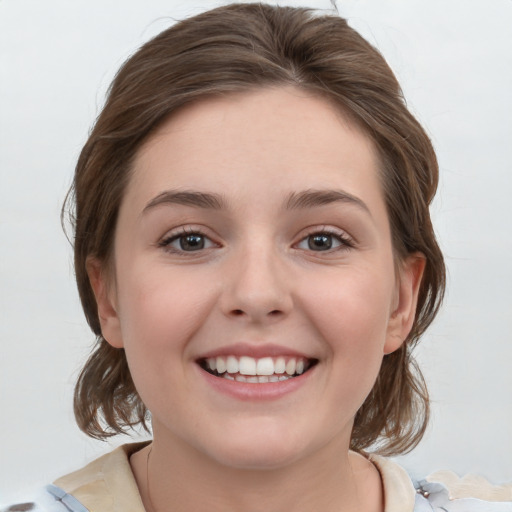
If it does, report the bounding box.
[198,355,318,384]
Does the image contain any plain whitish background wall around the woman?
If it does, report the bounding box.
[0,0,512,502]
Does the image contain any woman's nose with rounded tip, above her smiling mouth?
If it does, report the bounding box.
[221,245,293,323]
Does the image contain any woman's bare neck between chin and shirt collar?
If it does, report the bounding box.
[130,428,382,512]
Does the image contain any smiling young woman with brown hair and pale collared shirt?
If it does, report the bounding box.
[3,5,512,512]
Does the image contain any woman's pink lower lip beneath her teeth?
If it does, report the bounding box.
[198,366,316,401]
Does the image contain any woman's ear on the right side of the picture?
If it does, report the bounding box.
[384,252,426,354]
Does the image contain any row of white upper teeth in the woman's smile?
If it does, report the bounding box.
[207,356,306,375]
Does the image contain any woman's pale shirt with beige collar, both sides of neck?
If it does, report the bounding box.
[0,443,512,512]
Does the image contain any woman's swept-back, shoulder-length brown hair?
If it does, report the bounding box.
[67,4,445,454]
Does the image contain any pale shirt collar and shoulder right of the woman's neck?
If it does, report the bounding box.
[369,455,512,512]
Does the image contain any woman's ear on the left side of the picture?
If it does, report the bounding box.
[86,257,123,348]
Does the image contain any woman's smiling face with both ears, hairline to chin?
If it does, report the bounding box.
[89,88,423,468]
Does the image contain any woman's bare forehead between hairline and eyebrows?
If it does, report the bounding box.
[127,87,380,215]
